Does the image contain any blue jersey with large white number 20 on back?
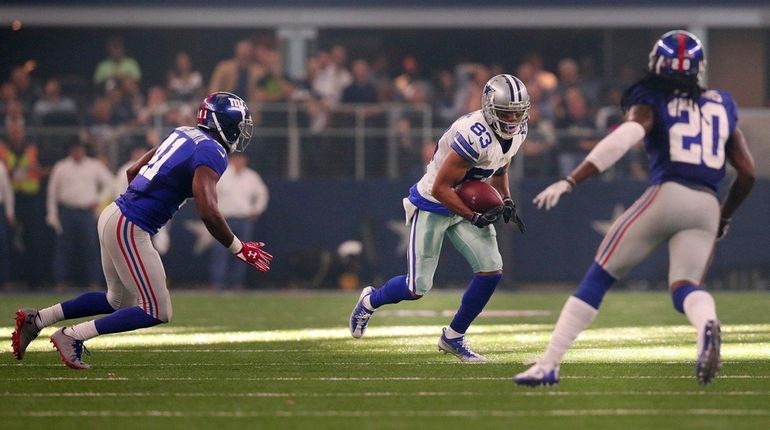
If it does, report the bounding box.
[626,84,738,192]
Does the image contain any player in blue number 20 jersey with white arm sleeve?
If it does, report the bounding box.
[514,30,754,385]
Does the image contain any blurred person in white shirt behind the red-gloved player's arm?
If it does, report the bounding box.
[209,152,270,289]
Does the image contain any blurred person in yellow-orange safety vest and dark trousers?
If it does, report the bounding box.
[0,122,49,288]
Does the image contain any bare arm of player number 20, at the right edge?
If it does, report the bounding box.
[717,128,756,238]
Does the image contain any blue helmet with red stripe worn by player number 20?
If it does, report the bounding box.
[648,30,706,81]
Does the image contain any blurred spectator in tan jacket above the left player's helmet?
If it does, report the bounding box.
[209,40,264,101]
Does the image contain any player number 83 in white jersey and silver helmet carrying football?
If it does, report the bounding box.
[350,75,530,362]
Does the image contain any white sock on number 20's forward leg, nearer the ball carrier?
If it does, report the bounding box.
[539,296,599,367]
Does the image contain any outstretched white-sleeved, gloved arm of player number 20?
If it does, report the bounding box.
[532,105,655,210]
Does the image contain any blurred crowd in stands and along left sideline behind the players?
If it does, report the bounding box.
[0,37,646,286]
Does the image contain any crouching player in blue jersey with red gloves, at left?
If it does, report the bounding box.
[12,92,273,369]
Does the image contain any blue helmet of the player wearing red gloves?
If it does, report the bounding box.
[198,91,254,153]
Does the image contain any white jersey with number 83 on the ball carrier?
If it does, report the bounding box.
[409,110,527,216]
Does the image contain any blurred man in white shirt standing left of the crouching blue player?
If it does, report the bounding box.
[46,140,114,287]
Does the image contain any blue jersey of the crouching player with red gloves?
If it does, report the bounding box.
[115,127,227,234]
